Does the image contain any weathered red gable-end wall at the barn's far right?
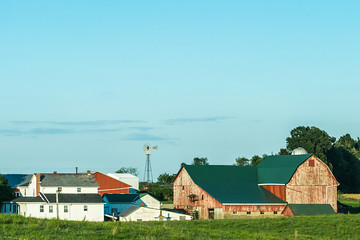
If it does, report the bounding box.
[286,156,339,212]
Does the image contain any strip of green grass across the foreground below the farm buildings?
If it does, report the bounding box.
[0,214,360,239]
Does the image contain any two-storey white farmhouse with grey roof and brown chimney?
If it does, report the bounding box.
[11,172,105,221]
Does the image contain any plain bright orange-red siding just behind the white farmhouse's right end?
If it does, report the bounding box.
[94,172,131,196]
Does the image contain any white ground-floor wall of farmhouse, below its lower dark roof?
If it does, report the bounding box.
[19,203,104,222]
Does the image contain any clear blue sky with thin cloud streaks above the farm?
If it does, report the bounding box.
[0,0,360,178]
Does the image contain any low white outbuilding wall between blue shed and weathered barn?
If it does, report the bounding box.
[120,207,192,222]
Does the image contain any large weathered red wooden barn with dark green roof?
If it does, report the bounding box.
[174,154,339,219]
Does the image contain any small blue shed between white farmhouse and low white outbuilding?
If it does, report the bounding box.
[103,194,142,216]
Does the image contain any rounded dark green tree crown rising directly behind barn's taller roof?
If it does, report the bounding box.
[286,126,336,164]
